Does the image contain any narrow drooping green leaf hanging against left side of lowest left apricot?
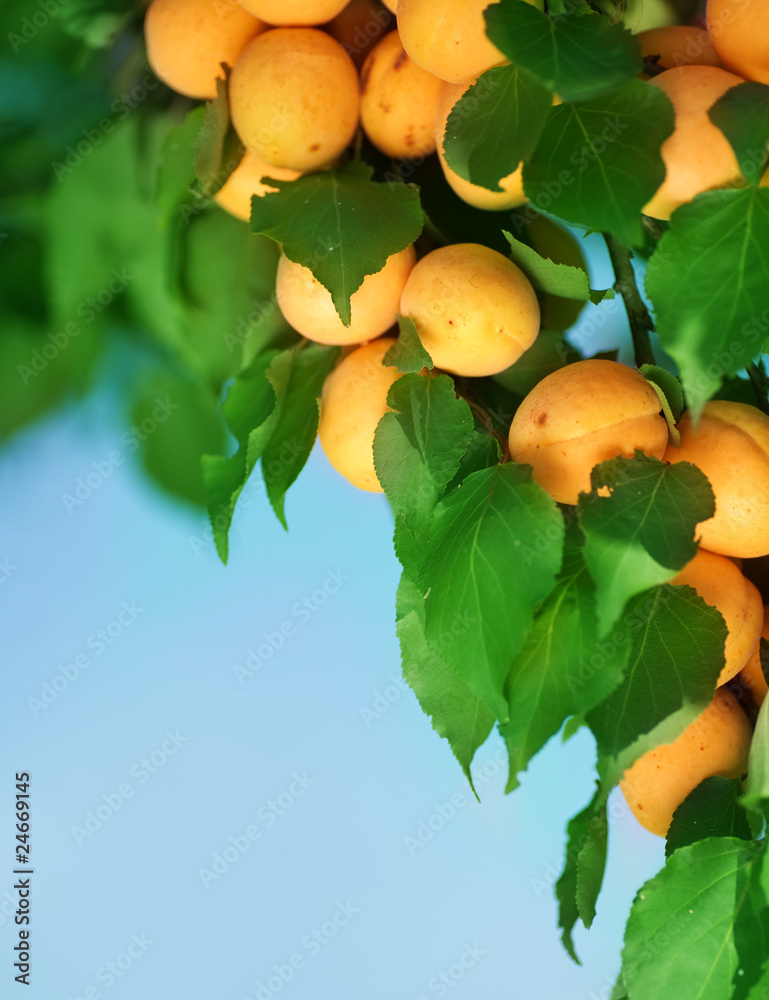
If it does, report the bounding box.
[262,341,339,529]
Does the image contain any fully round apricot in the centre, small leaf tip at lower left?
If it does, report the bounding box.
[400,243,539,376]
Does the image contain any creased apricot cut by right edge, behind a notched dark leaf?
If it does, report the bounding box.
[665,399,769,559]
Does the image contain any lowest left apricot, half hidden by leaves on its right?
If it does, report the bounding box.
[318,337,400,493]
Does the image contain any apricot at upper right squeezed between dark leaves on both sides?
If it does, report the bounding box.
[643,66,745,220]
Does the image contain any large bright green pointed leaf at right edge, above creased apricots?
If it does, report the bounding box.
[646,188,769,419]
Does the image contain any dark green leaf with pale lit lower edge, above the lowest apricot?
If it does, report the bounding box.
[586,585,727,784]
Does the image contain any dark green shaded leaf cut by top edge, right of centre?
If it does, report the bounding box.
[484,0,643,101]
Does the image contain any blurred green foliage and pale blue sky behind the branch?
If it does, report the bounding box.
[0,0,664,1000]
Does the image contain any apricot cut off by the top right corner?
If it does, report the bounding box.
[706,0,769,83]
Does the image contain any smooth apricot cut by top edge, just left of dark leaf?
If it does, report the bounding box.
[398,0,507,83]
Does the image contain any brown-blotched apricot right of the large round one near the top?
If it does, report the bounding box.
[360,31,443,159]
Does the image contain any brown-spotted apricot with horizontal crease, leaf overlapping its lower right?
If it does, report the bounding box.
[509,359,668,504]
